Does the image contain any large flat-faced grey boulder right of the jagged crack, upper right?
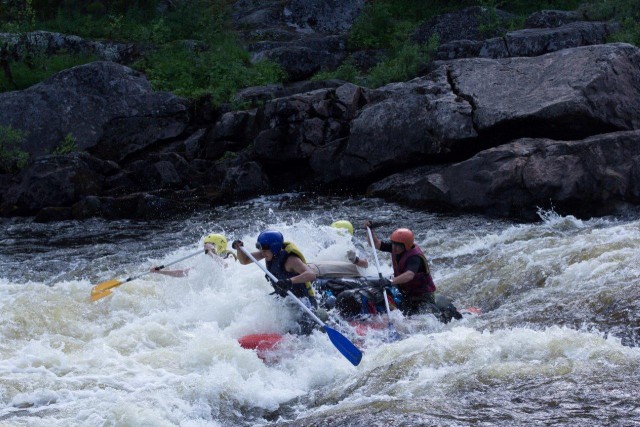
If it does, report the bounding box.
[447,43,640,142]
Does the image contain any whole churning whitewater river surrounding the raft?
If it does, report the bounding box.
[0,195,640,427]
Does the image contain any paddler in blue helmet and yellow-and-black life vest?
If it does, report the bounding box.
[231,230,318,335]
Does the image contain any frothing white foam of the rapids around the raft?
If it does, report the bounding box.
[0,210,640,426]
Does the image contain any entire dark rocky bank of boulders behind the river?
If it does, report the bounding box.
[0,0,640,221]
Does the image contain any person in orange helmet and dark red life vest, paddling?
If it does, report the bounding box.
[364,221,462,323]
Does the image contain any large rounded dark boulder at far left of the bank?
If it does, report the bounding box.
[0,62,189,160]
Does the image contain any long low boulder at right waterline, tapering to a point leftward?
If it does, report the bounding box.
[369,130,640,219]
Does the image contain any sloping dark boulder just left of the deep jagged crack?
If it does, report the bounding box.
[340,71,478,180]
